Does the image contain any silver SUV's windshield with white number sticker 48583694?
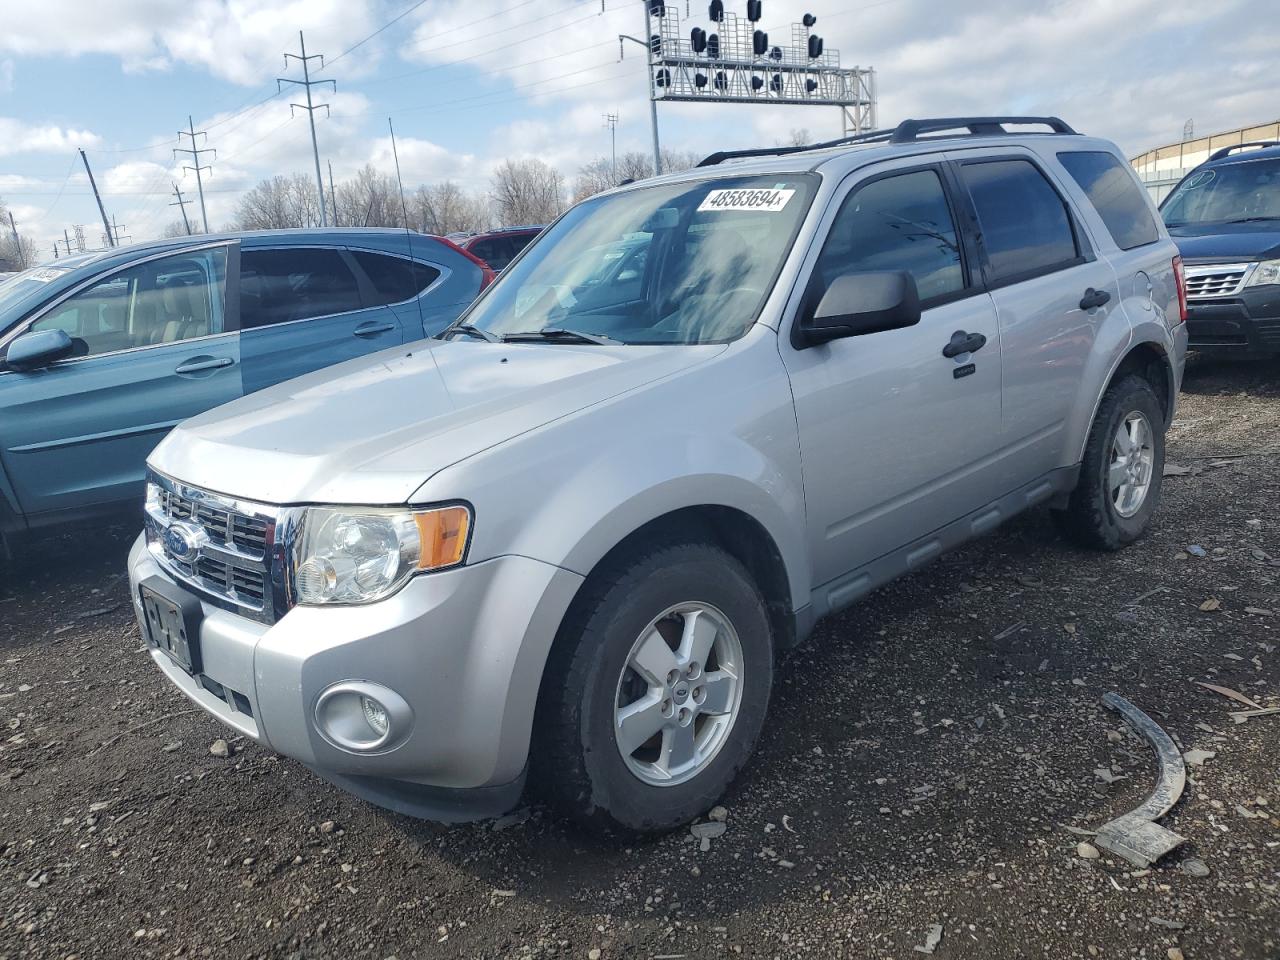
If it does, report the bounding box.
[442,174,815,343]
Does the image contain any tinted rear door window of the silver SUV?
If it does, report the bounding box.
[960,160,1079,283]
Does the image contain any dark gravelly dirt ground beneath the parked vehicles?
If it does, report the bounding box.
[0,361,1280,960]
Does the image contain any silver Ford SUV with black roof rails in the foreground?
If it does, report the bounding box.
[129,118,1187,831]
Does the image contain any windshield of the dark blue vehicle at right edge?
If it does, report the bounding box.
[1160,159,1280,227]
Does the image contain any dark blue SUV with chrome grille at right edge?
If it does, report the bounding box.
[1160,141,1280,356]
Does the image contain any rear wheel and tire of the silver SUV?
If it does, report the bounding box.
[1053,375,1165,550]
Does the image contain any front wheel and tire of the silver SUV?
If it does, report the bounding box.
[532,544,773,833]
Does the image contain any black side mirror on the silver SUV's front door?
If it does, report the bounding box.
[796,270,920,347]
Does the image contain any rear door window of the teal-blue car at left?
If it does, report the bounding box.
[241,247,362,330]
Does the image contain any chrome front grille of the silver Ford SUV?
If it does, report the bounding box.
[145,470,292,623]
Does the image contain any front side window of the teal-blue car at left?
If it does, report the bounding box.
[31,247,227,357]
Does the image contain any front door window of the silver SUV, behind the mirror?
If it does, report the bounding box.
[814,170,965,303]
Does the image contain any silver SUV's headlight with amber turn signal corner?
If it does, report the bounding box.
[293,507,471,604]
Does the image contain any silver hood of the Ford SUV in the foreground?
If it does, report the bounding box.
[147,339,724,504]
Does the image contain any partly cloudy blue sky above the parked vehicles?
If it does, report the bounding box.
[0,0,1280,257]
